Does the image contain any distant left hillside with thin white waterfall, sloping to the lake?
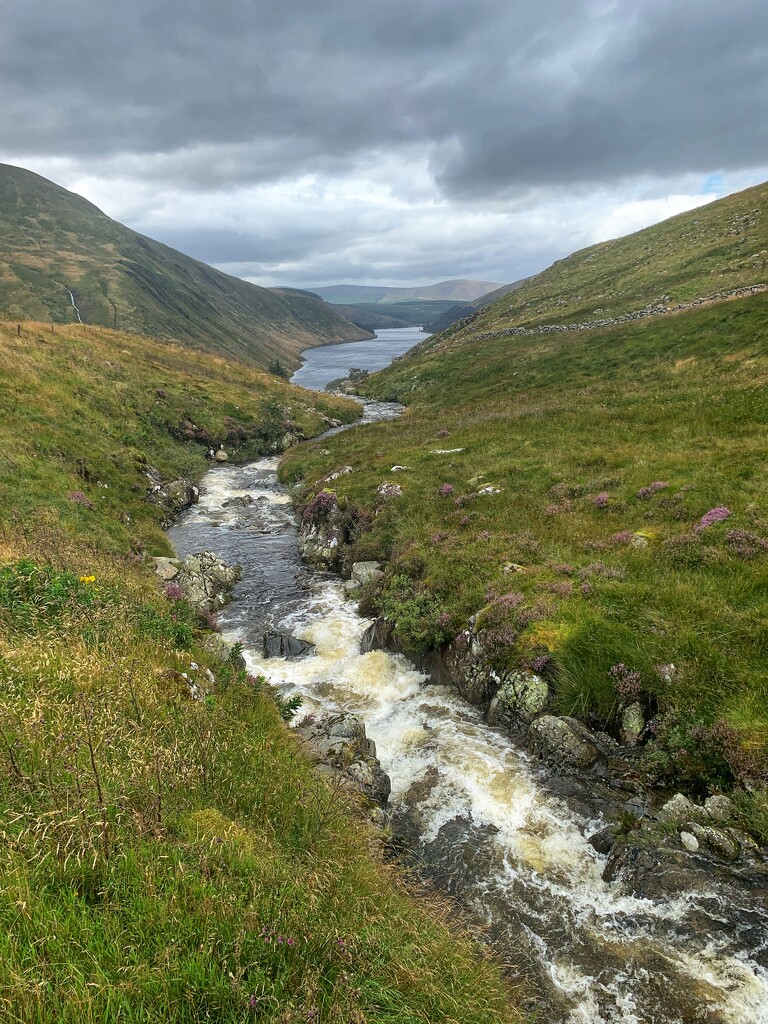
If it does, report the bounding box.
[0,164,370,367]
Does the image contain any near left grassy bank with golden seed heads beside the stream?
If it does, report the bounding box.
[0,325,517,1024]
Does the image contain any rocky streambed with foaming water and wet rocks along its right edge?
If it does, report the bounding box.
[163,414,768,1024]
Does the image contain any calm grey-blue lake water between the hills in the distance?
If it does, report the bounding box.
[291,327,428,391]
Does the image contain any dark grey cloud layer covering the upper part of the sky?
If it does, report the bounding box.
[0,0,768,197]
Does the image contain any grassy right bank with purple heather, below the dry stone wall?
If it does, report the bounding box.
[283,293,768,823]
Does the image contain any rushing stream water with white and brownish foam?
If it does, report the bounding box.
[171,336,768,1024]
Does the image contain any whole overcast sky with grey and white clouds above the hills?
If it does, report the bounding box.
[0,0,768,287]
